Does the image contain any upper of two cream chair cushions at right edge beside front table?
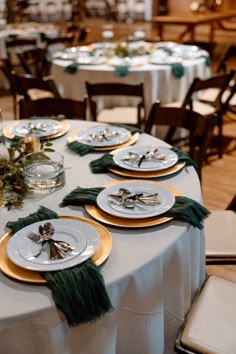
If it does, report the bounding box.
[204,210,236,257]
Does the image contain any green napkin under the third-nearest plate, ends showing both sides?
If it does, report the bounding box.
[89,147,198,173]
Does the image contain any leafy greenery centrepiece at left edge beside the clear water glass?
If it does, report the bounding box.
[0,137,54,210]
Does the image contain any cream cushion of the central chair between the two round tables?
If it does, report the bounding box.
[97,107,138,124]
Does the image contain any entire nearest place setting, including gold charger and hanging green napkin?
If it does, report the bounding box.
[0,206,112,326]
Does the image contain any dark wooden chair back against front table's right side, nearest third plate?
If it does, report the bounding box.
[145,102,216,180]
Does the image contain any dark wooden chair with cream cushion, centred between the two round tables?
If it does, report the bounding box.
[85,82,145,128]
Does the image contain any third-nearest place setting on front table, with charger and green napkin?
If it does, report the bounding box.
[90,145,197,179]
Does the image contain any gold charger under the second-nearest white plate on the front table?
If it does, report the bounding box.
[85,180,180,228]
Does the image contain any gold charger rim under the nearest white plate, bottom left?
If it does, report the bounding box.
[0,215,112,284]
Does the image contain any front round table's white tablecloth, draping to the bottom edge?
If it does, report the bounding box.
[0,120,205,354]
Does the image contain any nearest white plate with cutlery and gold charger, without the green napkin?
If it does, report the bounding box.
[0,215,112,283]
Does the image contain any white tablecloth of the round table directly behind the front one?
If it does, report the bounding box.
[51,41,211,112]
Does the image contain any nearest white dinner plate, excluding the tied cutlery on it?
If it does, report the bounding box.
[7,219,100,272]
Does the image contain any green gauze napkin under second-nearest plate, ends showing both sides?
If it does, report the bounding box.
[60,187,210,230]
